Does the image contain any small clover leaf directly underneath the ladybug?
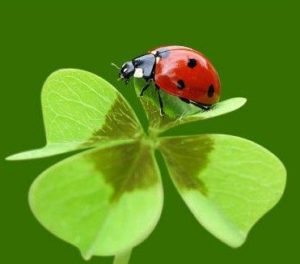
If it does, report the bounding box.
[134,80,247,134]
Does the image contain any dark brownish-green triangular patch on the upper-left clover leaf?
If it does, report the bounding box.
[84,96,142,146]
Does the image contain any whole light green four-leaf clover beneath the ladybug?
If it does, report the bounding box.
[7,69,286,264]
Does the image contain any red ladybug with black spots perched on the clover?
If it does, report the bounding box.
[119,46,220,116]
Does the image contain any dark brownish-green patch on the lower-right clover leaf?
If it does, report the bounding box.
[159,135,214,196]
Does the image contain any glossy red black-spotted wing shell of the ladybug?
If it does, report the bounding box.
[151,46,220,105]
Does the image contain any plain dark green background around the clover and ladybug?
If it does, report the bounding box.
[0,0,300,264]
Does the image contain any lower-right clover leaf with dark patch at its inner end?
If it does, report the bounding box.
[160,135,286,247]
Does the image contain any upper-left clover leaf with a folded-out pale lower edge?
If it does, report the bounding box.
[7,69,142,160]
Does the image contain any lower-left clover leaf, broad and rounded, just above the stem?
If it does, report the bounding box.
[29,141,163,259]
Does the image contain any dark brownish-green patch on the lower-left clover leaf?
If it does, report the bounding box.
[87,141,157,202]
